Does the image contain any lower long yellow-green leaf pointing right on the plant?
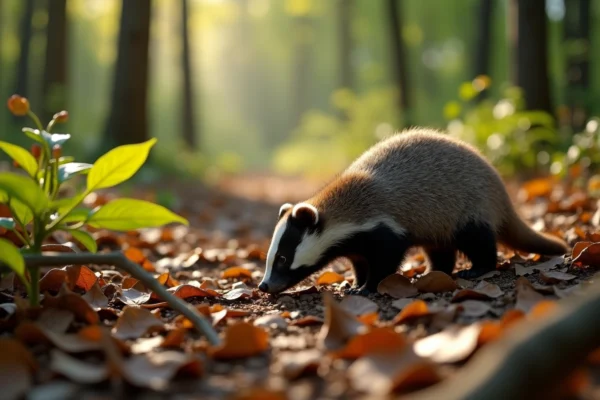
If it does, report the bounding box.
[88,199,188,231]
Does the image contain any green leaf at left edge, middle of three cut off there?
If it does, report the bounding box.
[0,173,48,215]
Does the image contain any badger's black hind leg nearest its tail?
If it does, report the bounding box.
[455,222,498,279]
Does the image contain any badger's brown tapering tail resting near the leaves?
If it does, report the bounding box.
[498,209,569,255]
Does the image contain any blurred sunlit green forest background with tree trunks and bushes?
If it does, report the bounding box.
[0,0,600,183]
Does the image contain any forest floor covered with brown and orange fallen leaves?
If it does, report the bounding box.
[0,173,600,399]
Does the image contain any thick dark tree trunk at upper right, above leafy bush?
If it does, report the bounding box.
[509,0,552,114]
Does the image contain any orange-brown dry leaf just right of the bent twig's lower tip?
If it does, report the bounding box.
[208,322,269,360]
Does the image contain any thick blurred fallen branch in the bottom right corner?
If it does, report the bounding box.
[407,282,600,400]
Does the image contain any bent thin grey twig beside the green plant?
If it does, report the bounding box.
[23,252,220,345]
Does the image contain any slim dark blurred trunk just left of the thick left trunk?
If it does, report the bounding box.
[42,0,68,121]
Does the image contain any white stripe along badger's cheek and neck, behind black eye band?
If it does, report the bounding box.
[290,217,406,270]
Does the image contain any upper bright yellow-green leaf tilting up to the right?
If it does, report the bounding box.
[87,138,156,192]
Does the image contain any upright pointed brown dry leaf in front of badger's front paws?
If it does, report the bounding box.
[318,292,366,351]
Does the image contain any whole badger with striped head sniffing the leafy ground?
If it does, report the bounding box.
[259,128,567,294]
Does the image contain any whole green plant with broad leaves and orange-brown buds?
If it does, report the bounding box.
[0,95,188,306]
